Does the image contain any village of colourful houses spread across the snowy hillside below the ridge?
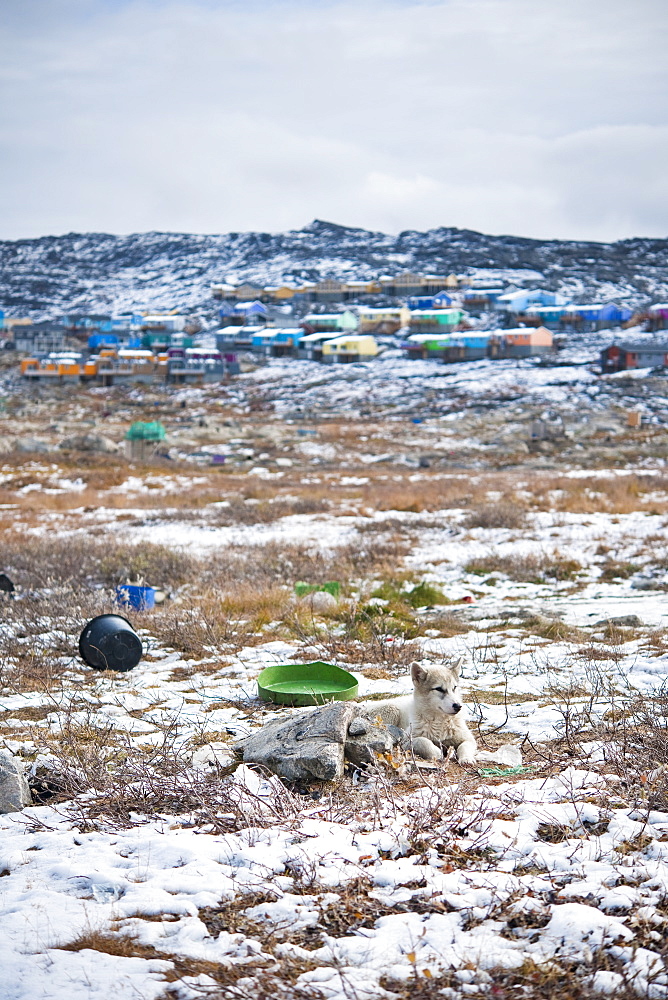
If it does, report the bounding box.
[0,272,668,386]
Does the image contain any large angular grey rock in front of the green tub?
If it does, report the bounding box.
[235,701,358,781]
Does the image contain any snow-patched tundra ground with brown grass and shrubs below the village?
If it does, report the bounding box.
[0,368,668,1000]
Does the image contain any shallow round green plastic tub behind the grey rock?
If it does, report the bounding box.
[257,660,358,705]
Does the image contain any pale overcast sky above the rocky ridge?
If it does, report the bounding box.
[0,0,668,240]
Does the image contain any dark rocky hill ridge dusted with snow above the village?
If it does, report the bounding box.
[0,220,668,318]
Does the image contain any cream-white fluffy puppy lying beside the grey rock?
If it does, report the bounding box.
[363,661,477,764]
